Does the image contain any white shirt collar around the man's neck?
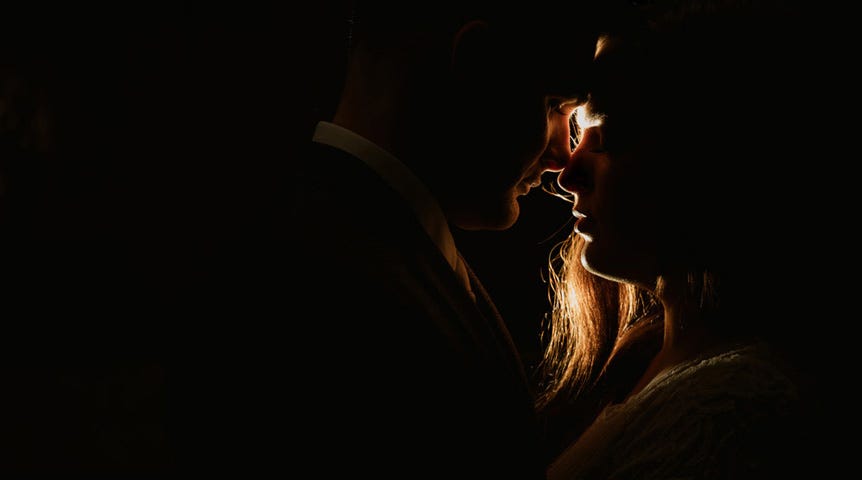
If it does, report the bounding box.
[313,121,470,280]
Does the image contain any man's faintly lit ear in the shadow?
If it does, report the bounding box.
[451,20,492,82]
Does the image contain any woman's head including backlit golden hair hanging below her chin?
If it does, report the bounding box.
[548,0,821,404]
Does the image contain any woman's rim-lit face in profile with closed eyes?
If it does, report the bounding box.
[557,39,684,289]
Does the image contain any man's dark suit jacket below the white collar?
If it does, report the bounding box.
[279,144,544,480]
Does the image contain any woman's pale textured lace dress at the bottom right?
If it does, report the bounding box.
[548,345,810,480]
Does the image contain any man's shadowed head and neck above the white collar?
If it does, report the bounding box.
[334,0,612,230]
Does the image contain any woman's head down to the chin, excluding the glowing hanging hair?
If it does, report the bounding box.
[559,2,810,289]
